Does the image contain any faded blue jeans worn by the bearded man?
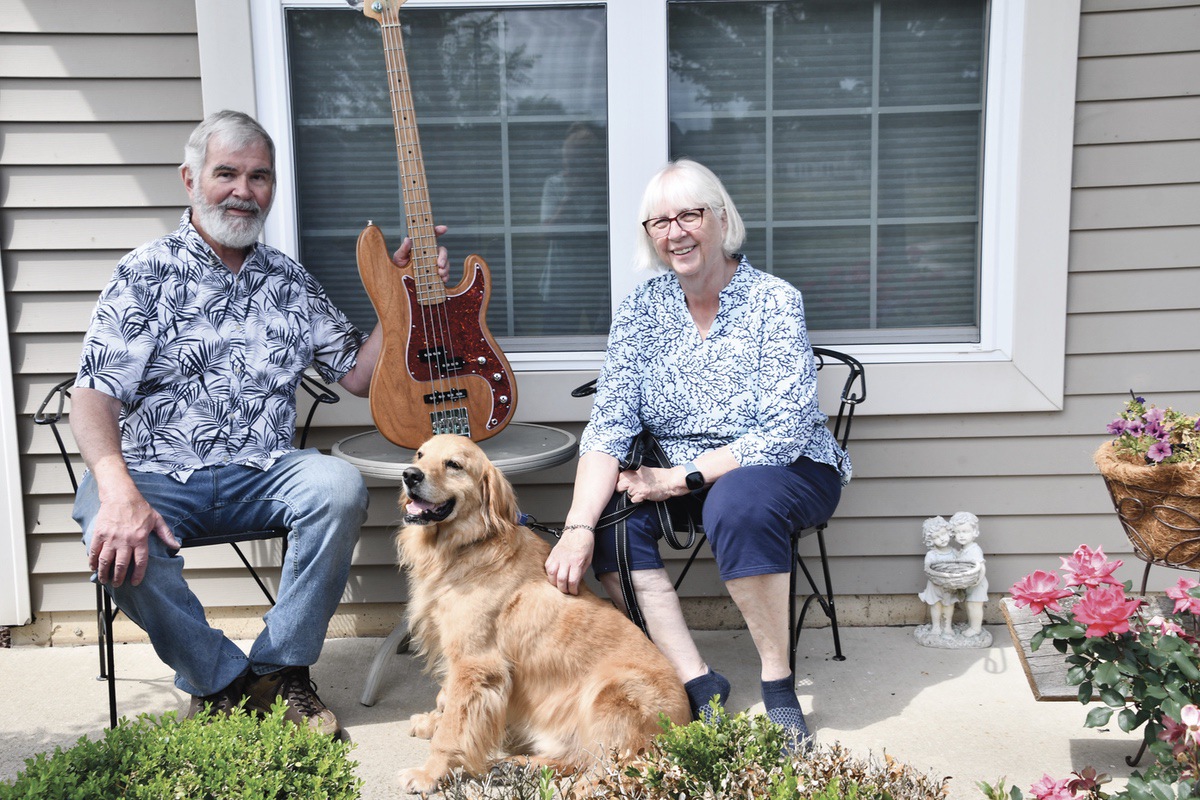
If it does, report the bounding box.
[73,450,367,696]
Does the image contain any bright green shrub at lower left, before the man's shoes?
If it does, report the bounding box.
[0,704,361,800]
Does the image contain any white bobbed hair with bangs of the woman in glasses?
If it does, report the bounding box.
[634,158,746,271]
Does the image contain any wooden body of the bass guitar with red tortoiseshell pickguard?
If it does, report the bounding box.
[358,224,516,450]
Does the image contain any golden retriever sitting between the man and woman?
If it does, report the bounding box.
[397,434,691,793]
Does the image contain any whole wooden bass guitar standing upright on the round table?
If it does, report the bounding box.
[350,0,517,450]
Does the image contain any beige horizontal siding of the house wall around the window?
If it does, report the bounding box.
[0,0,1200,636]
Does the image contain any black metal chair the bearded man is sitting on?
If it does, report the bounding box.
[34,375,341,728]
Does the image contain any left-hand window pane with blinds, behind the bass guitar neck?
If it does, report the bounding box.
[286,6,611,351]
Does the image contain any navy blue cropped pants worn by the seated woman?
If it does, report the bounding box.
[592,456,841,581]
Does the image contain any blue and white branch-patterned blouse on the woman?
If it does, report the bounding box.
[580,257,851,485]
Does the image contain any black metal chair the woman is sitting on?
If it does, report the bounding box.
[571,348,866,674]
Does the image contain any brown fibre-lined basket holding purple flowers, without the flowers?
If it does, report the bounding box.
[1093,441,1200,569]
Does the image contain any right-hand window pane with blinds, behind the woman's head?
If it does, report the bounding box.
[667,0,986,344]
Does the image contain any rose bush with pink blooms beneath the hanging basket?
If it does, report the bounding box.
[998,545,1200,800]
